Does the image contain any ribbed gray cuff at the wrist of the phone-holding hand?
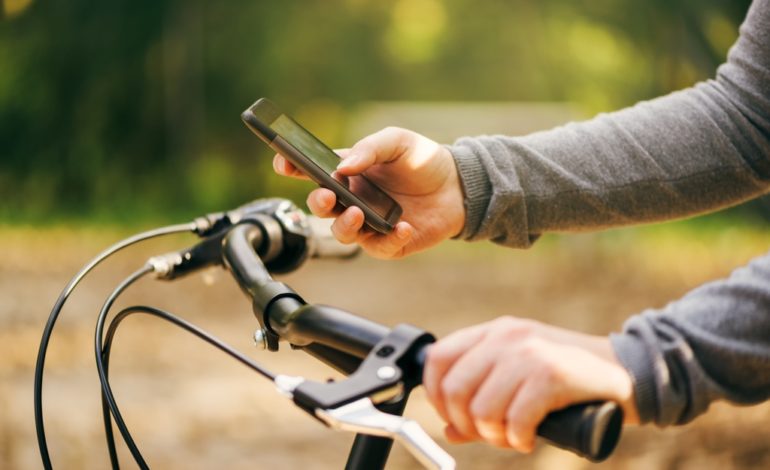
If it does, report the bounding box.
[447,145,492,240]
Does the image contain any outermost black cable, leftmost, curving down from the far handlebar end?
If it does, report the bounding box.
[33,223,196,470]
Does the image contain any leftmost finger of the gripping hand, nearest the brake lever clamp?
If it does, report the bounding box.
[422,324,487,422]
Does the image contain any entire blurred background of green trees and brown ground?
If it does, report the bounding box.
[0,0,770,469]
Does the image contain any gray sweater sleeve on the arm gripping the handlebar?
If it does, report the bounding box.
[610,253,770,426]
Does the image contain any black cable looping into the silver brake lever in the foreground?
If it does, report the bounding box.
[97,304,275,468]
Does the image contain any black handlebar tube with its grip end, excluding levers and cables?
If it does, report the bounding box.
[222,216,623,462]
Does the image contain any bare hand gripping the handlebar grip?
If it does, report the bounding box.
[423,317,639,452]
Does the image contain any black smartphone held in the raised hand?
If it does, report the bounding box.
[241,98,402,233]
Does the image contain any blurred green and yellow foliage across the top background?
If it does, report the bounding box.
[0,0,750,221]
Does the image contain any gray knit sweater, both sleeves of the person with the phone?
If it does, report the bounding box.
[450,0,770,426]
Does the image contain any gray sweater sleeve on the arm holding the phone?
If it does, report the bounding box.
[450,0,770,247]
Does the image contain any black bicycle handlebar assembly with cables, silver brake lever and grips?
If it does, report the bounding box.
[34,199,623,469]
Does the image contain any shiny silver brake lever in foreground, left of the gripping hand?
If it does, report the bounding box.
[275,375,456,470]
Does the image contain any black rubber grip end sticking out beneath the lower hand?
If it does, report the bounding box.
[537,401,623,462]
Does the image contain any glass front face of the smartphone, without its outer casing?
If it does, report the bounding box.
[270,114,398,219]
